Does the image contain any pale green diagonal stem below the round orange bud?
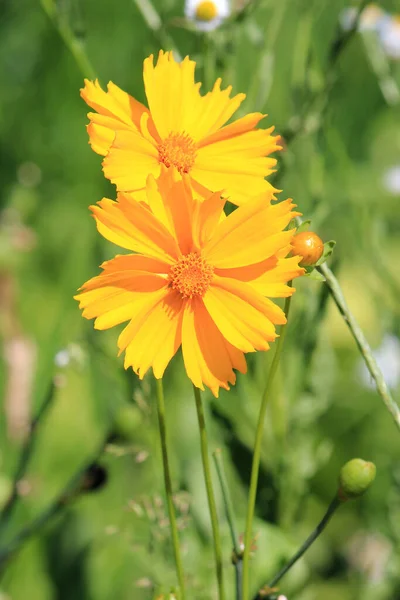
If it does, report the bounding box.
[318,263,400,429]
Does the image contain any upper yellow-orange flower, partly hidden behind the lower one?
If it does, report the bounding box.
[81,50,279,205]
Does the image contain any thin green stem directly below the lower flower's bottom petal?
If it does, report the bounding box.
[193,385,225,600]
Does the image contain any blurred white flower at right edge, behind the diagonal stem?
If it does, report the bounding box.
[358,334,400,389]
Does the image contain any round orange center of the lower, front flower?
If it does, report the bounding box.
[169,252,214,298]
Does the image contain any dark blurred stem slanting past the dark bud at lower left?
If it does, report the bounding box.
[0,434,110,569]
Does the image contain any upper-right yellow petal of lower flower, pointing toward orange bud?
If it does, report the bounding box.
[204,195,298,268]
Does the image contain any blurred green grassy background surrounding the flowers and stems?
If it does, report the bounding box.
[0,0,400,600]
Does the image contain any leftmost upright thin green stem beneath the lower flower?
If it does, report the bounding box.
[157,379,185,600]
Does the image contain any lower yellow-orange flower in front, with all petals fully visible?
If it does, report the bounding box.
[76,173,303,396]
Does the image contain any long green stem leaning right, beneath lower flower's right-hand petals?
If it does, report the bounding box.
[242,296,291,600]
